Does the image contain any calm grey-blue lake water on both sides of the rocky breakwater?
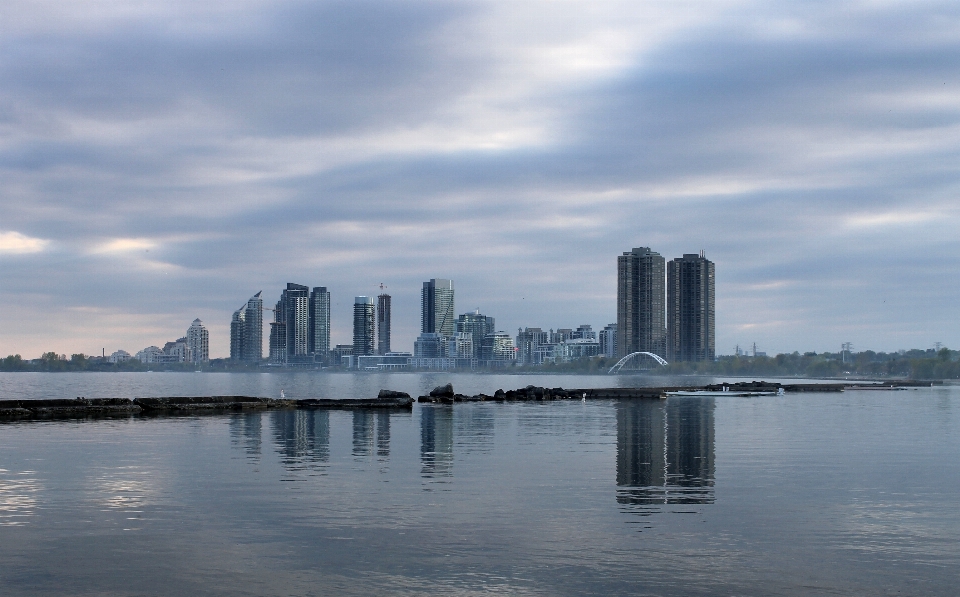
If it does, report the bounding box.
[0,373,960,596]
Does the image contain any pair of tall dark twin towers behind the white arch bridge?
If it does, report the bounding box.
[617,247,716,361]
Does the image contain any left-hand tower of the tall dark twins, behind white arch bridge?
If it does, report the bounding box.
[617,247,667,357]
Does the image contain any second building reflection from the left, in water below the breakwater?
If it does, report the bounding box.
[270,409,330,466]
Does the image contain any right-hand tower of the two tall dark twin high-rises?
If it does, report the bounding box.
[665,252,716,361]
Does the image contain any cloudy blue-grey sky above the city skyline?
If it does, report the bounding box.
[0,0,960,358]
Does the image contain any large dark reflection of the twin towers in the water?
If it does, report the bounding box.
[617,397,715,511]
